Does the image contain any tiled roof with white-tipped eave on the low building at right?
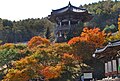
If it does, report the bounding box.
[95,41,120,60]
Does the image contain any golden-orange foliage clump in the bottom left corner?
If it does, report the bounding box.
[2,56,43,81]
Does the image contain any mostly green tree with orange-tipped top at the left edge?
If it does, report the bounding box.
[0,43,31,81]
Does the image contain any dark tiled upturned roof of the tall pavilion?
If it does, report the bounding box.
[48,2,93,22]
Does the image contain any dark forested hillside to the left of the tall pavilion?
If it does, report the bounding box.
[0,18,54,43]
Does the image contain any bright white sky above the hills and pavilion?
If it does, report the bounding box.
[0,0,106,21]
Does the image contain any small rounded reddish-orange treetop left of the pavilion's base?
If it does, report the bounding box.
[28,36,50,48]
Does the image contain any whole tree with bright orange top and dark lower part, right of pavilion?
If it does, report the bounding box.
[68,27,105,59]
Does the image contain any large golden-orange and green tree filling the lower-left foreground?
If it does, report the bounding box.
[2,41,81,81]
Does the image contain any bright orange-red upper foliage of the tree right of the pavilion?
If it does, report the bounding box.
[68,27,105,47]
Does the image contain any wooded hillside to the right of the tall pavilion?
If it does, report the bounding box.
[82,0,120,30]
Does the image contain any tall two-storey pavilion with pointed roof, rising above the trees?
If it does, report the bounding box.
[49,2,93,42]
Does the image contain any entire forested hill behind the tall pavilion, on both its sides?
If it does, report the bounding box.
[0,0,120,43]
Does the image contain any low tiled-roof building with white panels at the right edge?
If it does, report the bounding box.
[93,15,120,81]
